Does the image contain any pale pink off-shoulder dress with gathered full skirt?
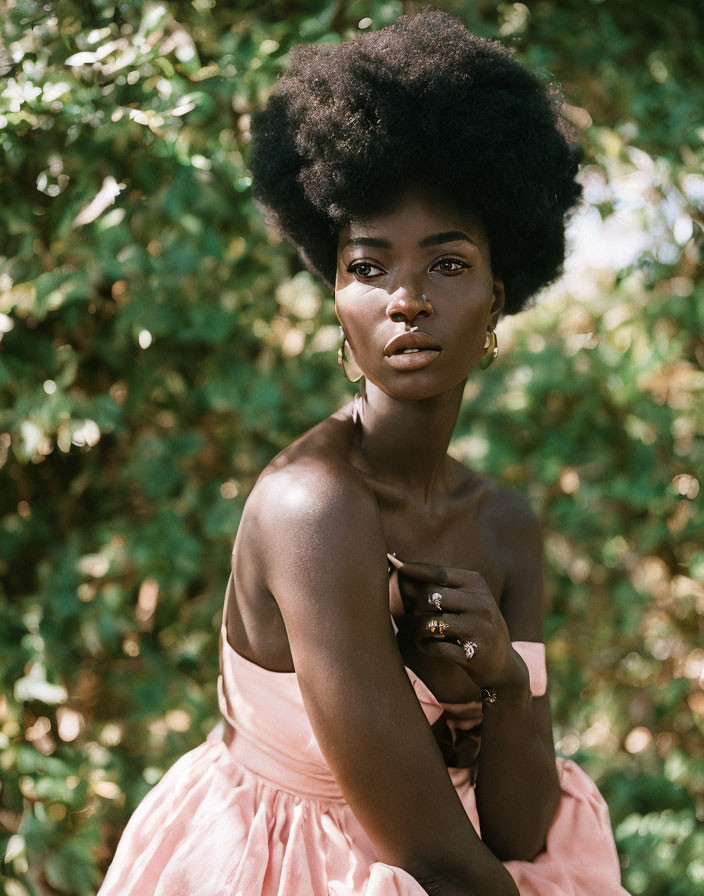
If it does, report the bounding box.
[98,596,627,896]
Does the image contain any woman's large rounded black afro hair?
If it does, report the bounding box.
[250,10,581,314]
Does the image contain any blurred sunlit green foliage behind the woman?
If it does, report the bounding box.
[0,0,704,896]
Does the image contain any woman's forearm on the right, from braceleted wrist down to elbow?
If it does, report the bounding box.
[476,682,560,861]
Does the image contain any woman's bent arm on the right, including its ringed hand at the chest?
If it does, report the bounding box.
[400,496,560,861]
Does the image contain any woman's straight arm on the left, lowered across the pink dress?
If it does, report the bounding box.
[250,464,517,896]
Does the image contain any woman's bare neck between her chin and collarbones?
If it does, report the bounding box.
[355,382,464,503]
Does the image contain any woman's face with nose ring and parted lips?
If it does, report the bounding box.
[335,192,504,400]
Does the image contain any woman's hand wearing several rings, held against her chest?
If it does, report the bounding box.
[394,558,529,692]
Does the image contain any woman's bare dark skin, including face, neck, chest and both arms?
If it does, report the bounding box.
[227,192,559,896]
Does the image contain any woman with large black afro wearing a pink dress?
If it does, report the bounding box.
[101,11,623,896]
